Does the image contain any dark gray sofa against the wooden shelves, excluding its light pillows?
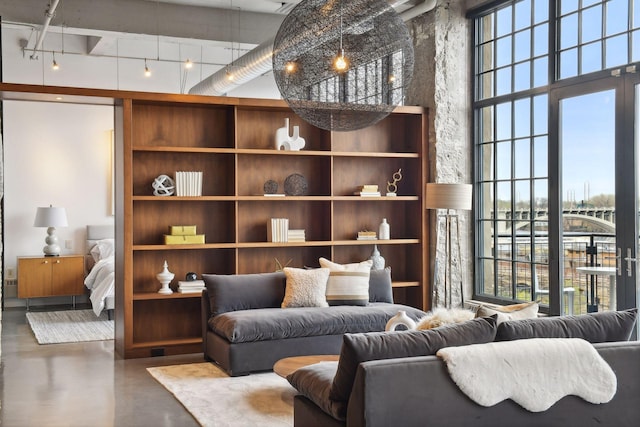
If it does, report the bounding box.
[202,269,425,376]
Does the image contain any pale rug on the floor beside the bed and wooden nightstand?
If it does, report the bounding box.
[27,310,114,344]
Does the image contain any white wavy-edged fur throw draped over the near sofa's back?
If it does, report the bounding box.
[437,338,617,412]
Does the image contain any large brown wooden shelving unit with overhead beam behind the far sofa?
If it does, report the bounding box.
[0,84,430,358]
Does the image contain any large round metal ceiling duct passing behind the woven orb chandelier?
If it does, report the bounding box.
[189,0,437,96]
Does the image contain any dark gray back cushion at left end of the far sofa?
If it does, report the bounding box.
[202,271,285,316]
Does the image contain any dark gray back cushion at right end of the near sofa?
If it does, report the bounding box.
[496,308,638,343]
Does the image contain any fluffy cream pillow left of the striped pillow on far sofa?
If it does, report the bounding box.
[282,267,329,308]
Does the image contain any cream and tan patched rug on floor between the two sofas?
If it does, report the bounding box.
[147,363,296,427]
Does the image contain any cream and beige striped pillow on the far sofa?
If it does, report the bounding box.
[319,258,373,305]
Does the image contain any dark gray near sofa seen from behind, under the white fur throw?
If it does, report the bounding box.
[287,310,640,427]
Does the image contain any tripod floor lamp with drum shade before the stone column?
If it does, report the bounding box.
[425,183,472,308]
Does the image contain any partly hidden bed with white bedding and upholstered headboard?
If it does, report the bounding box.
[84,225,115,319]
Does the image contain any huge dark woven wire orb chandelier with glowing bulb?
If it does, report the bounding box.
[273,0,414,131]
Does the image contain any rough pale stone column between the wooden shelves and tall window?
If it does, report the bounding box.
[406,0,473,306]
